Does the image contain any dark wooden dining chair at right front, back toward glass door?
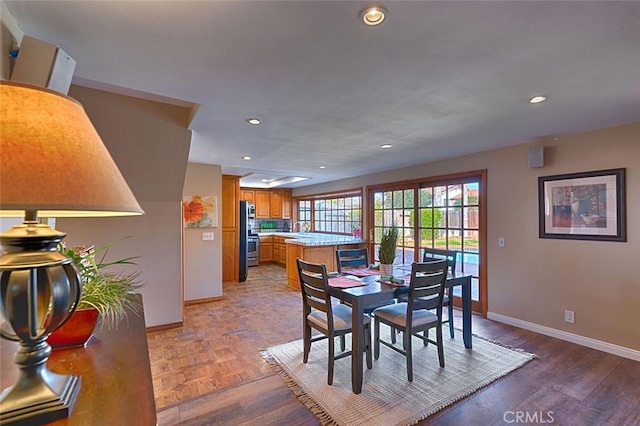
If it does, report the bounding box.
[373,259,448,382]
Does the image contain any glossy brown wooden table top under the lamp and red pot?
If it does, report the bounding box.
[0,295,156,426]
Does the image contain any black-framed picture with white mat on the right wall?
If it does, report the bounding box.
[538,168,627,242]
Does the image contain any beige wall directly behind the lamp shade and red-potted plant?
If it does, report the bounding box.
[56,85,191,327]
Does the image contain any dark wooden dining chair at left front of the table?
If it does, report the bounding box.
[297,259,373,385]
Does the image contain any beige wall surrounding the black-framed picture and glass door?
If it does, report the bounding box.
[293,123,640,351]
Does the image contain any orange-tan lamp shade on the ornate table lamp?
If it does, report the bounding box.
[0,81,144,217]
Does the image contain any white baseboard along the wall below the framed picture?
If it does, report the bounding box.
[487,312,640,361]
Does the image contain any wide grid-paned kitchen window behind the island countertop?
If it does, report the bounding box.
[298,191,362,235]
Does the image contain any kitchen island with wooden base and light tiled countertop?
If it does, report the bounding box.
[276,232,367,289]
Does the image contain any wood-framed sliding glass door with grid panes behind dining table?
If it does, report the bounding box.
[368,171,486,315]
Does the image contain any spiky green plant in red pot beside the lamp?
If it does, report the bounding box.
[48,241,144,348]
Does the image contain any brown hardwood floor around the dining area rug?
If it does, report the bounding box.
[148,265,640,426]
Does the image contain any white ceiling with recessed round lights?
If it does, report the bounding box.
[5,1,640,188]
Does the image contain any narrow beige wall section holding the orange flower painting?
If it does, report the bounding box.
[184,163,222,301]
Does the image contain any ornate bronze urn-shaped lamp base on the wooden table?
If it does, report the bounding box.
[0,218,82,425]
